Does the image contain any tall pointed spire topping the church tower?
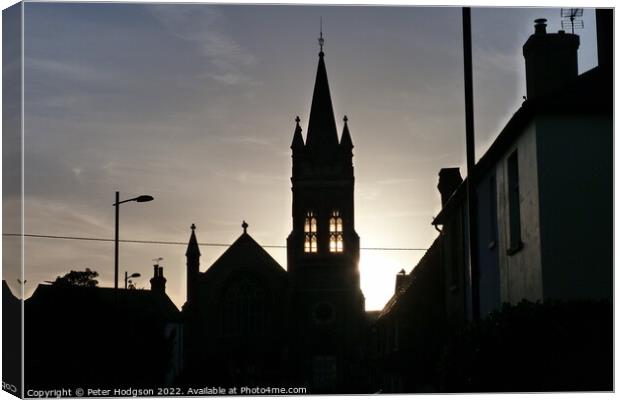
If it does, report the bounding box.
[306,24,338,158]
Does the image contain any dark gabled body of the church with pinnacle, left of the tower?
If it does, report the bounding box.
[183,224,288,387]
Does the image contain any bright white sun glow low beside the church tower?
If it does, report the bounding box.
[360,250,409,310]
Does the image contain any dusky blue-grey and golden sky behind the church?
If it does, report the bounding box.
[3,2,596,310]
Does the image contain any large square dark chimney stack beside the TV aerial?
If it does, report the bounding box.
[523,18,579,99]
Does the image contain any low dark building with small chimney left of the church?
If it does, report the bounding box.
[24,266,183,389]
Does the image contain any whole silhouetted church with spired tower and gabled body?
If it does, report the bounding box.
[182,34,369,393]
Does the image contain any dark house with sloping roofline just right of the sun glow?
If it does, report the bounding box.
[371,238,447,393]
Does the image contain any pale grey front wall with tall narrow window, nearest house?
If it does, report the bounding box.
[495,123,543,304]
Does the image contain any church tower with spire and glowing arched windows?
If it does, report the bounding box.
[287,33,365,393]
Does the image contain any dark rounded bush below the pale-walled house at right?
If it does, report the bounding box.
[439,301,613,392]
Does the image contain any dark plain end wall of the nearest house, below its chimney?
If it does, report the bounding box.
[536,114,613,299]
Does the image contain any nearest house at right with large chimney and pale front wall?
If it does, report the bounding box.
[433,10,613,318]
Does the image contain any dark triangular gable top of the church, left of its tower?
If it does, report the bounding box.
[204,231,286,278]
